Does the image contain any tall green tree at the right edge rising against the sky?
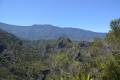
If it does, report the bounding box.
[107,18,120,49]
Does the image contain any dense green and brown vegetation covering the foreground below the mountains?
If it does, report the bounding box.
[0,19,120,80]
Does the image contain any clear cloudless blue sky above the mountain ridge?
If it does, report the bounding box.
[0,0,120,32]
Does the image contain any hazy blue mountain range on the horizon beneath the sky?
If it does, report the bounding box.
[0,23,106,41]
